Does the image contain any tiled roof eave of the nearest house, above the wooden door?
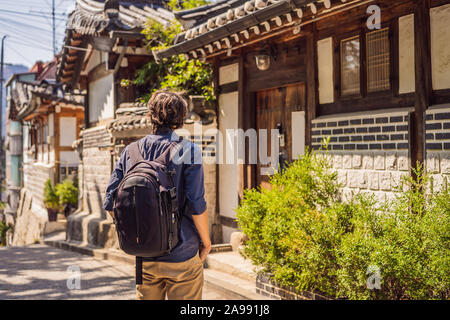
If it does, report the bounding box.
[153,0,362,60]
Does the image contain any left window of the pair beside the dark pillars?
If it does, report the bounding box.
[341,36,361,96]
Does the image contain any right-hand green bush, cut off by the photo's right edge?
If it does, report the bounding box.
[337,169,450,299]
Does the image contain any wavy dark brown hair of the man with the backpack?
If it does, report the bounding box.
[148,90,188,133]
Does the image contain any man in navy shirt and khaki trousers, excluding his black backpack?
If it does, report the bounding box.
[103,90,211,300]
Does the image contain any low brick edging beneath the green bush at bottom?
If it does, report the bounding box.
[256,274,331,300]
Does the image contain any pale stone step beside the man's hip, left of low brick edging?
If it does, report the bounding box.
[204,268,272,300]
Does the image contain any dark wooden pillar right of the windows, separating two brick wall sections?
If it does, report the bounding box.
[410,0,432,171]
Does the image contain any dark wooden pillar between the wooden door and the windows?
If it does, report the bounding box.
[305,23,319,147]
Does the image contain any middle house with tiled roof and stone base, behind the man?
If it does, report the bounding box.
[58,0,221,248]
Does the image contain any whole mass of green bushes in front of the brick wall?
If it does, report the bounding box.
[237,152,450,299]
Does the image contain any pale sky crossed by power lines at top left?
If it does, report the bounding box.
[0,0,75,67]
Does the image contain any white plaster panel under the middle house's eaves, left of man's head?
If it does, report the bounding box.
[89,73,114,122]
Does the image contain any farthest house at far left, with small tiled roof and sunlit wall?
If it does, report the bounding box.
[7,58,84,245]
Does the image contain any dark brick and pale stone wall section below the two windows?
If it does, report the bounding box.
[311,109,411,201]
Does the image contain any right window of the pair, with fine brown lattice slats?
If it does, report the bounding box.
[366,28,391,92]
